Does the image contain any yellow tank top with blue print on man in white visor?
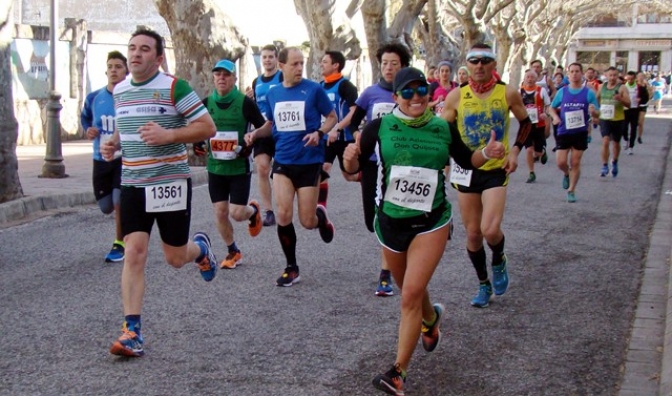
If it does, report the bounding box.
[457,81,509,170]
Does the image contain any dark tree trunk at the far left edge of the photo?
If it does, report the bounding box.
[0,0,23,203]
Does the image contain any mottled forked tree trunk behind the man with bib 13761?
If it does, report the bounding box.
[294,0,362,81]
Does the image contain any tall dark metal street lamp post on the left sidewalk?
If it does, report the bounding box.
[40,0,68,179]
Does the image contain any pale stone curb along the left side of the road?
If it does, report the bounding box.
[0,167,208,226]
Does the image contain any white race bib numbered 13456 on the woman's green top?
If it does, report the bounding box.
[385,165,437,212]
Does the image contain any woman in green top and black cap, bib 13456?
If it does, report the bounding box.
[344,67,505,395]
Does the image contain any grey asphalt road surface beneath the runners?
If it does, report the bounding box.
[0,118,672,396]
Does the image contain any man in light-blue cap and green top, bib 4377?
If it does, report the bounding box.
[197,59,271,269]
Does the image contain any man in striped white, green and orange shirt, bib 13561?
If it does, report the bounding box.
[100,28,217,357]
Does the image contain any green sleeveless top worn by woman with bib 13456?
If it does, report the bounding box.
[378,114,452,221]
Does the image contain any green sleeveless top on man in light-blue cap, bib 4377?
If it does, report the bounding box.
[207,89,250,176]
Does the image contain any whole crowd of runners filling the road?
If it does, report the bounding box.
[81,29,666,395]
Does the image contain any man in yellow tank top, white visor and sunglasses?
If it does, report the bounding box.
[441,43,532,308]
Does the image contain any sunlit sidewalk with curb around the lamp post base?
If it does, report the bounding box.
[0,140,207,227]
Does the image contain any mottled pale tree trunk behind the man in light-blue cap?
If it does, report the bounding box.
[155,0,248,97]
